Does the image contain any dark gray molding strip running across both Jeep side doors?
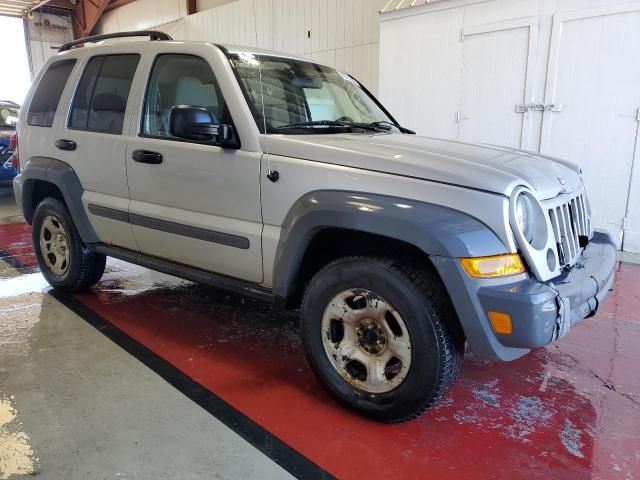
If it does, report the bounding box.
[88,203,251,250]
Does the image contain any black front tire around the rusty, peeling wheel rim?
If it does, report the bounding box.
[301,257,464,423]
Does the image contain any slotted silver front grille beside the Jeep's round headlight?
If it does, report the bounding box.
[545,191,591,267]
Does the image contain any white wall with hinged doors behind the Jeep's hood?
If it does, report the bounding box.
[380,0,640,251]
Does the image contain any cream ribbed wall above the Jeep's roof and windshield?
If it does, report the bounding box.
[97,0,387,92]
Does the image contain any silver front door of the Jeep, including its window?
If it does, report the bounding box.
[126,53,262,283]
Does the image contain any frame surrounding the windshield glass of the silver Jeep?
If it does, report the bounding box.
[216,45,403,135]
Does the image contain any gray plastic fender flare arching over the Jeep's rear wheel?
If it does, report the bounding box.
[17,157,98,244]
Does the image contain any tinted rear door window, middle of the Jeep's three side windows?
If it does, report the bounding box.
[69,55,140,135]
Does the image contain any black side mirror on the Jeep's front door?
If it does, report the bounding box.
[169,105,240,148]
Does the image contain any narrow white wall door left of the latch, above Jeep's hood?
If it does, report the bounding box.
[457,17,538,148]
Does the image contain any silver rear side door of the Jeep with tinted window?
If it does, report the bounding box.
[50,53,140,250]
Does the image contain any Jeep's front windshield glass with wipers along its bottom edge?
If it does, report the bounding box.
[231,54,395,133]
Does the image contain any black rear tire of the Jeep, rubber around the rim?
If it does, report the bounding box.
[32,198,106,292]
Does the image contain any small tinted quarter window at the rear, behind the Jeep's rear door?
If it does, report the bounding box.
[27,59,76,127]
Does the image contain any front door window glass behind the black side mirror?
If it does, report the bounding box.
[142,54,230,139]
